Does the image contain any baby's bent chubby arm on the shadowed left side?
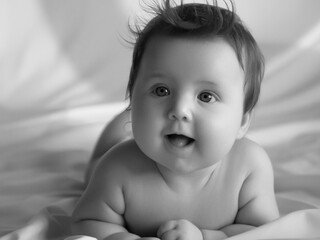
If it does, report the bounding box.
[72,147,156,240]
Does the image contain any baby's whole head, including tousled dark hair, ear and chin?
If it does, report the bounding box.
[128,0,263,173]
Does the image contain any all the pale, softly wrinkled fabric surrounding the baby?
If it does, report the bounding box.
[0,0,320,240]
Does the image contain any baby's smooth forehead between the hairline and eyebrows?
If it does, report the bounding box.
[138,36,244,87]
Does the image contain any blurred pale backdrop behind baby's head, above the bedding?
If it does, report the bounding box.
[0,0,320,123]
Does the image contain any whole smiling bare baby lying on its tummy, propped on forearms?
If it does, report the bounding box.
[73,0,279,240]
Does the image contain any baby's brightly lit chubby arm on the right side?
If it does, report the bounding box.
[223,143,279,236]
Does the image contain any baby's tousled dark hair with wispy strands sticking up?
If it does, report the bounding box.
[127,0,264,113]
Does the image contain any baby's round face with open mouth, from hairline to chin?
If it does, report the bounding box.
[131,37,244,173]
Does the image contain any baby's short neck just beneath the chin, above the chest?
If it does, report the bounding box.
[157,162,220,192]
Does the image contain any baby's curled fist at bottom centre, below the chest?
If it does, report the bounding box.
[157,219,203,240]
